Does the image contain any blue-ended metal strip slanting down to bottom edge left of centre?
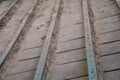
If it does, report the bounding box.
[34,0,61,80]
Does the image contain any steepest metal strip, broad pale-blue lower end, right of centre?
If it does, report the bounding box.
[82,0,98,80]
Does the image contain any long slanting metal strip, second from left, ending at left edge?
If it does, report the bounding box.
[0,0,38,66]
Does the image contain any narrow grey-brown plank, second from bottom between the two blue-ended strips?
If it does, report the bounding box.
[54,49,86,64]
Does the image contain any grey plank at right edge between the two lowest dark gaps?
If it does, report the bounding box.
[100,53,120,71]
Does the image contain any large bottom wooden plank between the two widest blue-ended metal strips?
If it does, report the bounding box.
[46,60,88,80]
